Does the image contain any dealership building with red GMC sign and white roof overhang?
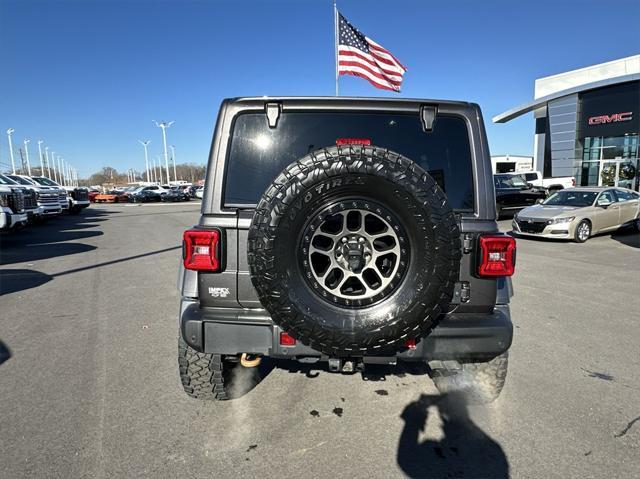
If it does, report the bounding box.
[493,55,640,191]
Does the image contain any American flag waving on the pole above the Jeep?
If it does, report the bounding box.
[338,13,407,92]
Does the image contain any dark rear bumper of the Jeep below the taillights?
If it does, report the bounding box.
[180,301,513,362]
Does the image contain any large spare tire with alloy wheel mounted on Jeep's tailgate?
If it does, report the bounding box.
[248,145,461,357]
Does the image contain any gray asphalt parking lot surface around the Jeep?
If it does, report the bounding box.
[0,203,640,478]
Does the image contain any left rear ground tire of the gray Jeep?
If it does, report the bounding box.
[178,337,261,401]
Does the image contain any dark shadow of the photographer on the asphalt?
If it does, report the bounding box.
[397,393,509,478]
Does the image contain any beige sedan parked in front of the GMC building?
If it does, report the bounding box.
[513,187,640,243]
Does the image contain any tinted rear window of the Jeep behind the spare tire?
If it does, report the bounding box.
[224,112,474,211]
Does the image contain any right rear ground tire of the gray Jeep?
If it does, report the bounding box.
[431,352,509,404]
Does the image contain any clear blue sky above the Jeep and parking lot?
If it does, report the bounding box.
[0,0,640,176]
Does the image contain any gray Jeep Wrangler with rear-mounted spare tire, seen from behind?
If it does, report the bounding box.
[178,97,515,401]
